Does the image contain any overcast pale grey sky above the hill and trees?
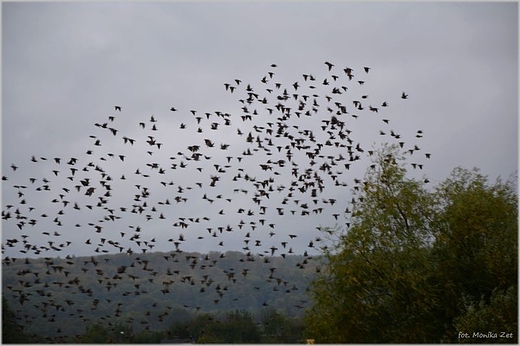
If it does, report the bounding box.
[2,2,518,256]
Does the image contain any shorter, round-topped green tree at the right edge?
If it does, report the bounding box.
[433,168,518,342]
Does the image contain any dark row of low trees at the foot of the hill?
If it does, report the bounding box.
[2,300,305,344]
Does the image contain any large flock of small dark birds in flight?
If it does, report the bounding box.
[2,62,430,338]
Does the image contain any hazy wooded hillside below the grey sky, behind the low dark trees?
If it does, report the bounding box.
[2,251,319,337]
